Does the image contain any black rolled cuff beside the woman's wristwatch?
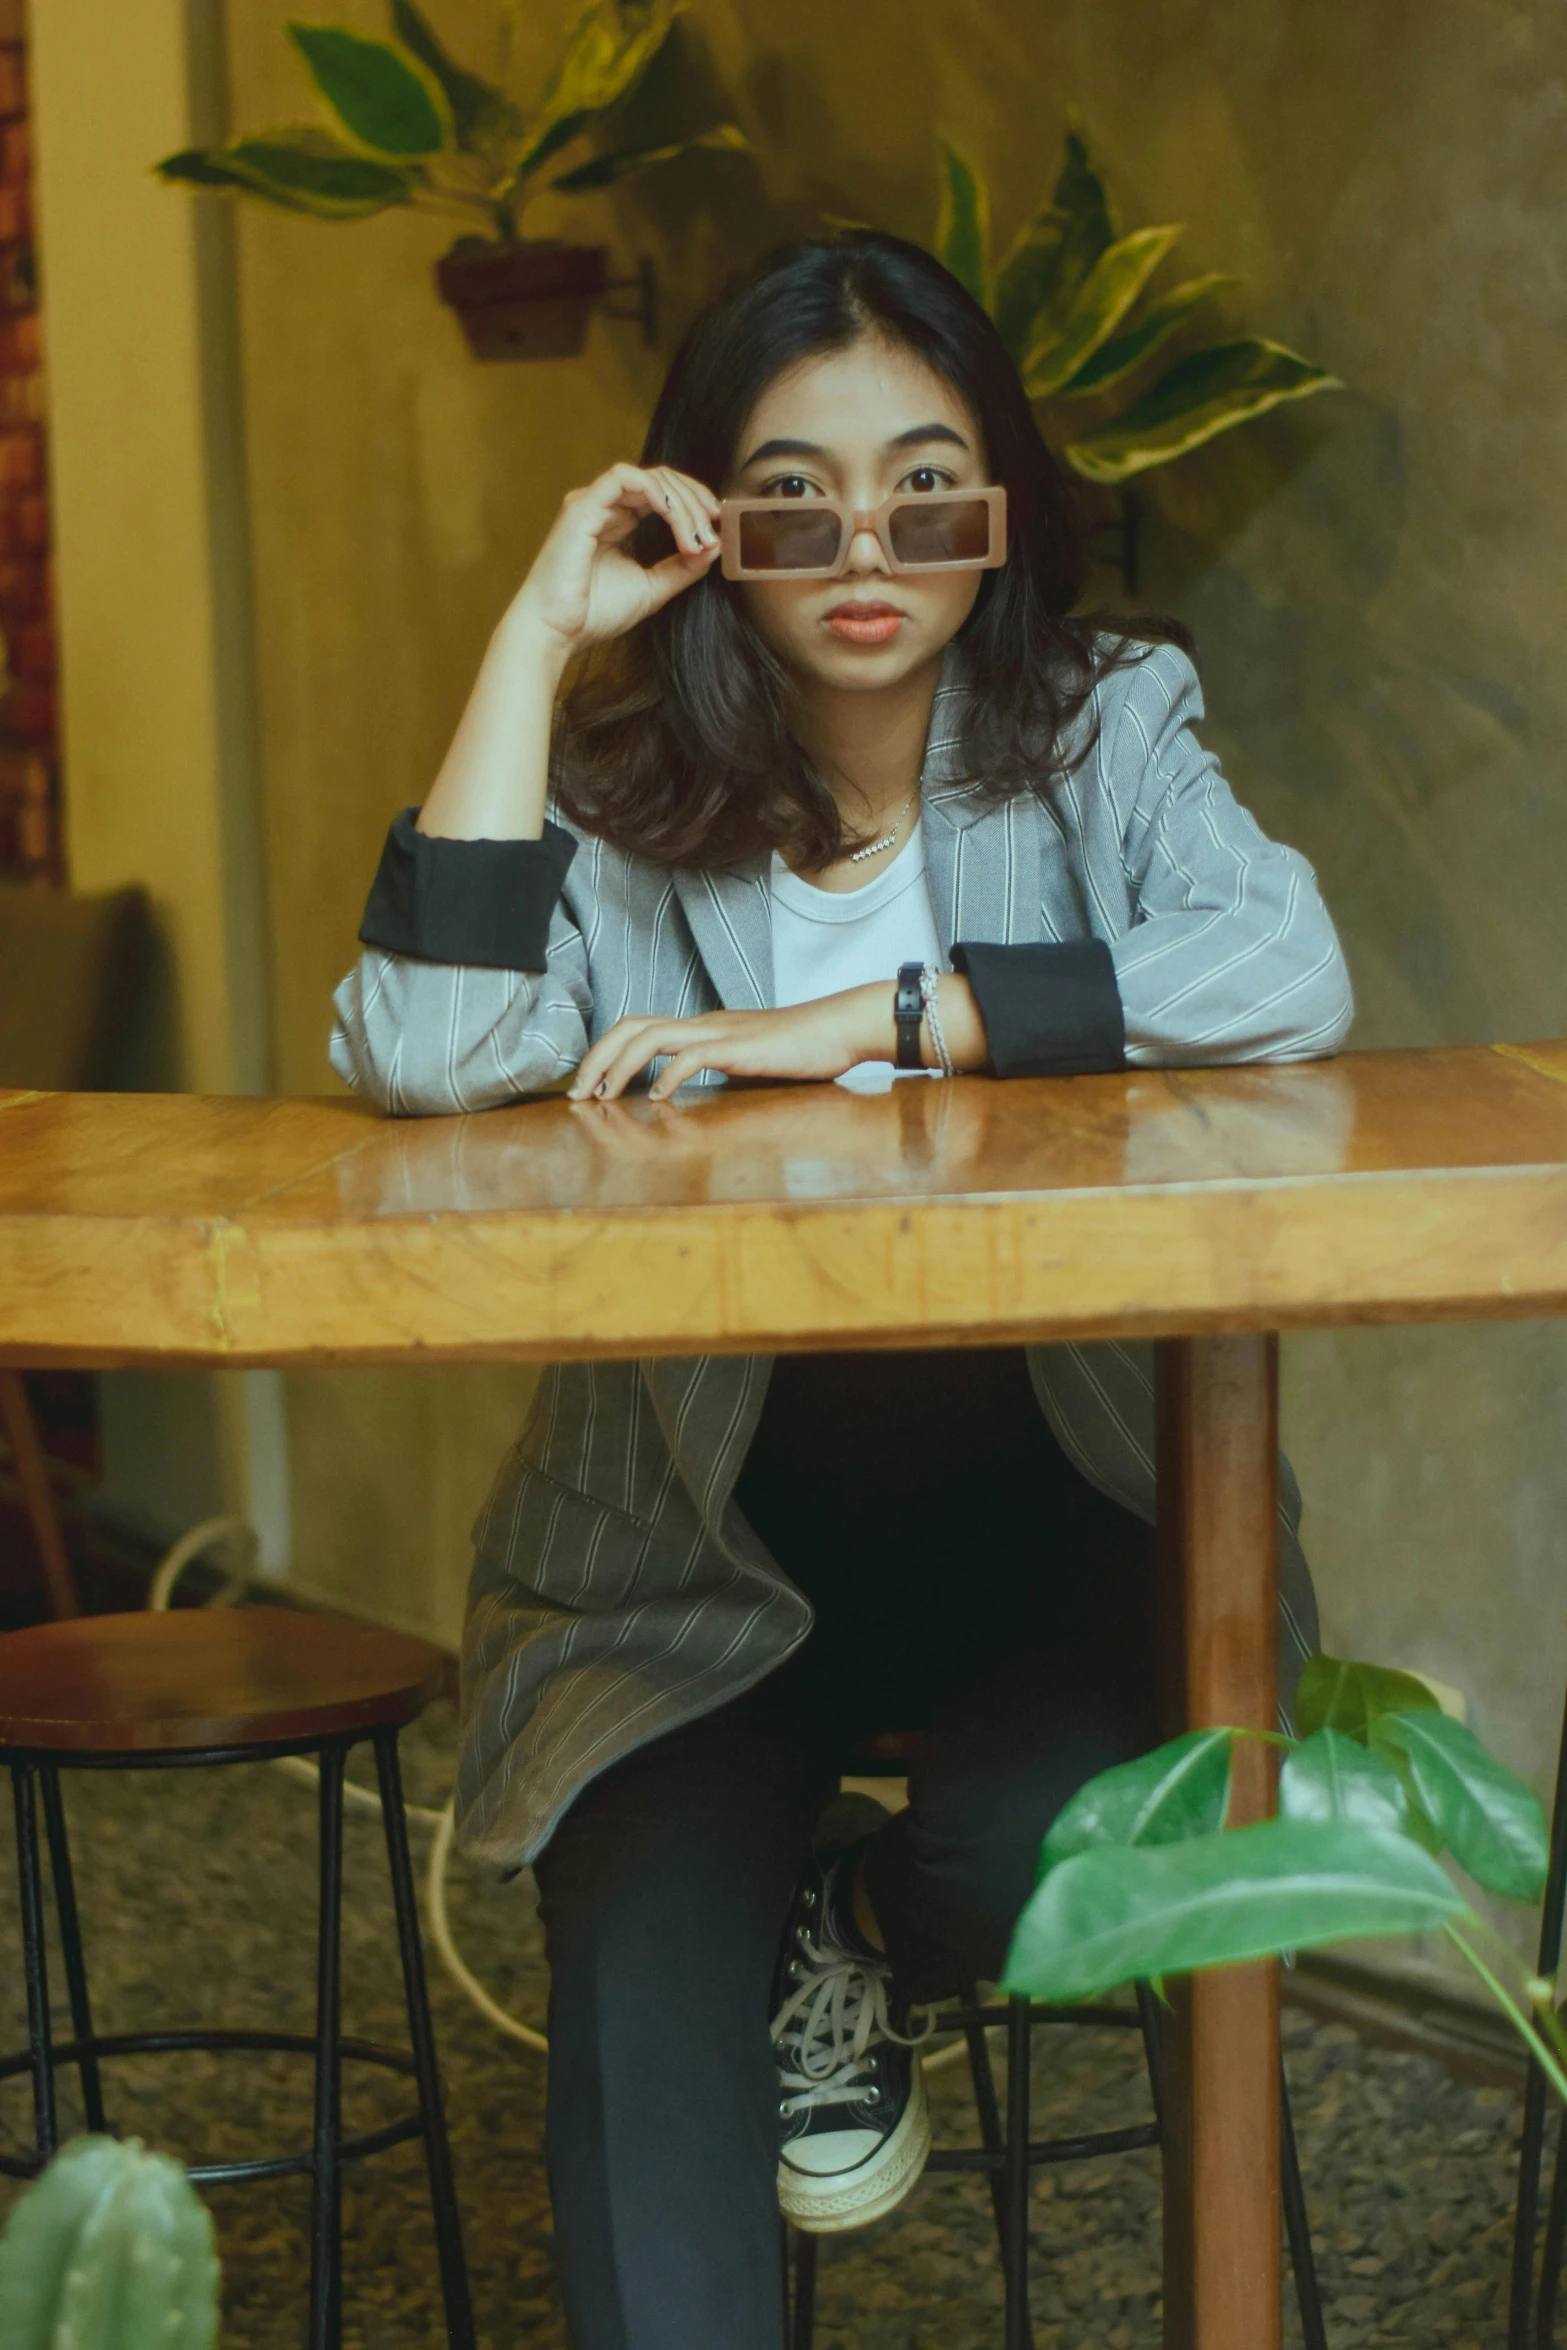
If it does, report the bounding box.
[951,938,1125,1076]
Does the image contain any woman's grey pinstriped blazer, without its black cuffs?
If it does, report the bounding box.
[331,646,1351,1871]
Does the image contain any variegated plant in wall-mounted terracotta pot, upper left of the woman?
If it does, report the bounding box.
[157,0,745,360]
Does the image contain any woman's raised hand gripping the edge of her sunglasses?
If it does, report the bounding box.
[507,465,719,658]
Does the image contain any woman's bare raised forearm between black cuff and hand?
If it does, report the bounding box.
[418,604,566,841]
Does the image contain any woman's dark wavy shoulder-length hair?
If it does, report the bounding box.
[557,230,1182,872]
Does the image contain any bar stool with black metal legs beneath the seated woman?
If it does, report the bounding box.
[785,1732,1327,2350]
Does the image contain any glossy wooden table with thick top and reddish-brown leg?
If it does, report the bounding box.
[0,1043,1567,2350]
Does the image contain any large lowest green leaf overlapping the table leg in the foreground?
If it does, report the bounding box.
[1003,1819,1464,2002]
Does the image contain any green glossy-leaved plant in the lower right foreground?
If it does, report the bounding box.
[1003,1657,1567,2103]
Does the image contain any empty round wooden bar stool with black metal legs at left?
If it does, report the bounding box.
[0,1607,475,2350]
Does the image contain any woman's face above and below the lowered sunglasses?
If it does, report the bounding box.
[724,334,989,691]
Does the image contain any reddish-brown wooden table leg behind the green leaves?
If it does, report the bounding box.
[1158,1337,1283,2350]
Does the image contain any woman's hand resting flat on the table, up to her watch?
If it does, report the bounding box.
[566,985,895,1102]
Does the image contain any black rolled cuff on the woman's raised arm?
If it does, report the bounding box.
[359,808,576,971]
